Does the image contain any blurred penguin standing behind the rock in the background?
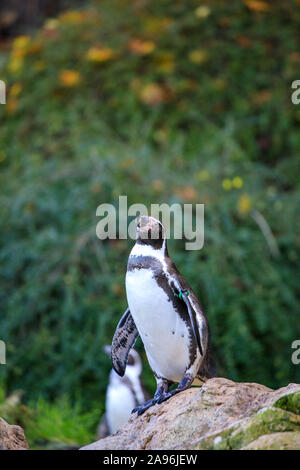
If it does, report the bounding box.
[97,345,149,439]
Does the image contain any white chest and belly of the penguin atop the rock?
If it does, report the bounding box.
[126,269,190,382]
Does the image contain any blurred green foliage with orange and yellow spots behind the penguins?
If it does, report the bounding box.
[0,0,300,447]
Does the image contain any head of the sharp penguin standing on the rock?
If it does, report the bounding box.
[136,215,166,249]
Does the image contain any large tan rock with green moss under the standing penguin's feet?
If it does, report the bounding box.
[82,378,300,450]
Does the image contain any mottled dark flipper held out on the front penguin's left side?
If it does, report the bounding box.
[111,308,139,377]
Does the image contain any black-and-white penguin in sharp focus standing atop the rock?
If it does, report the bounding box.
[111,216,217,415]
